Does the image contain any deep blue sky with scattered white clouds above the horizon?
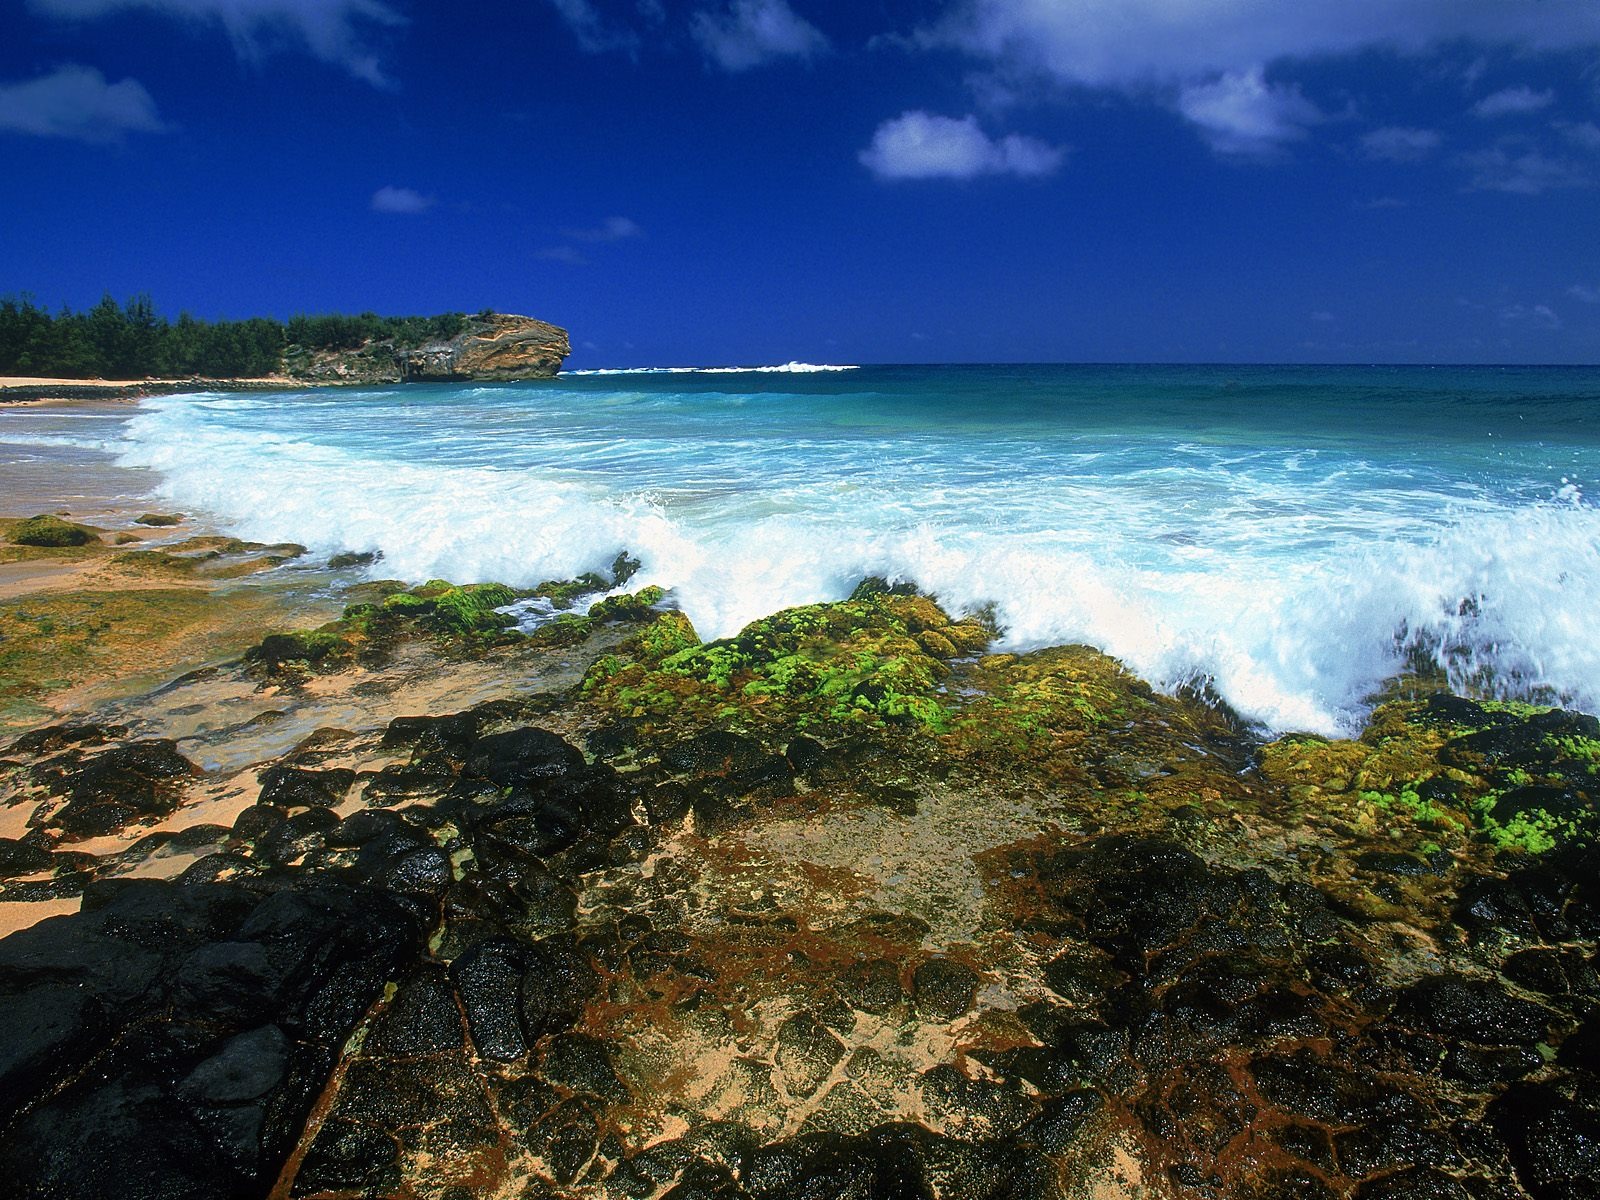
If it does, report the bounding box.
[0,0,1600,366]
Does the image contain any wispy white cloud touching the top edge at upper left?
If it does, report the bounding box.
[27,0,405,86]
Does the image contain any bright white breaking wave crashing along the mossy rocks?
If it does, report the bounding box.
[120,390,1600,734]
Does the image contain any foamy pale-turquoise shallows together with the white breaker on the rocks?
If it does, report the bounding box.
[120,376,1600,734]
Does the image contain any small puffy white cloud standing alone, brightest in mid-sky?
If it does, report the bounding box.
[858,112,1066,179]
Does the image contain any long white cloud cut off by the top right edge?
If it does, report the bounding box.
[920,0,1600,88]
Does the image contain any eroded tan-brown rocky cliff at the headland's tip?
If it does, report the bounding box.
[285,312,571,384]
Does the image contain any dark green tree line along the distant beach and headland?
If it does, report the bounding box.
[0,294,490,379]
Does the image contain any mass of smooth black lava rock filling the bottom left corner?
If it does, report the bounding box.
[0,878,422,1200]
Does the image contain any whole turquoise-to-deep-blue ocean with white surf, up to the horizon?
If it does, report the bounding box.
[0,365,1600,734]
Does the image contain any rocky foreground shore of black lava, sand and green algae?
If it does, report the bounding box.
[0,528,1600,1200]
